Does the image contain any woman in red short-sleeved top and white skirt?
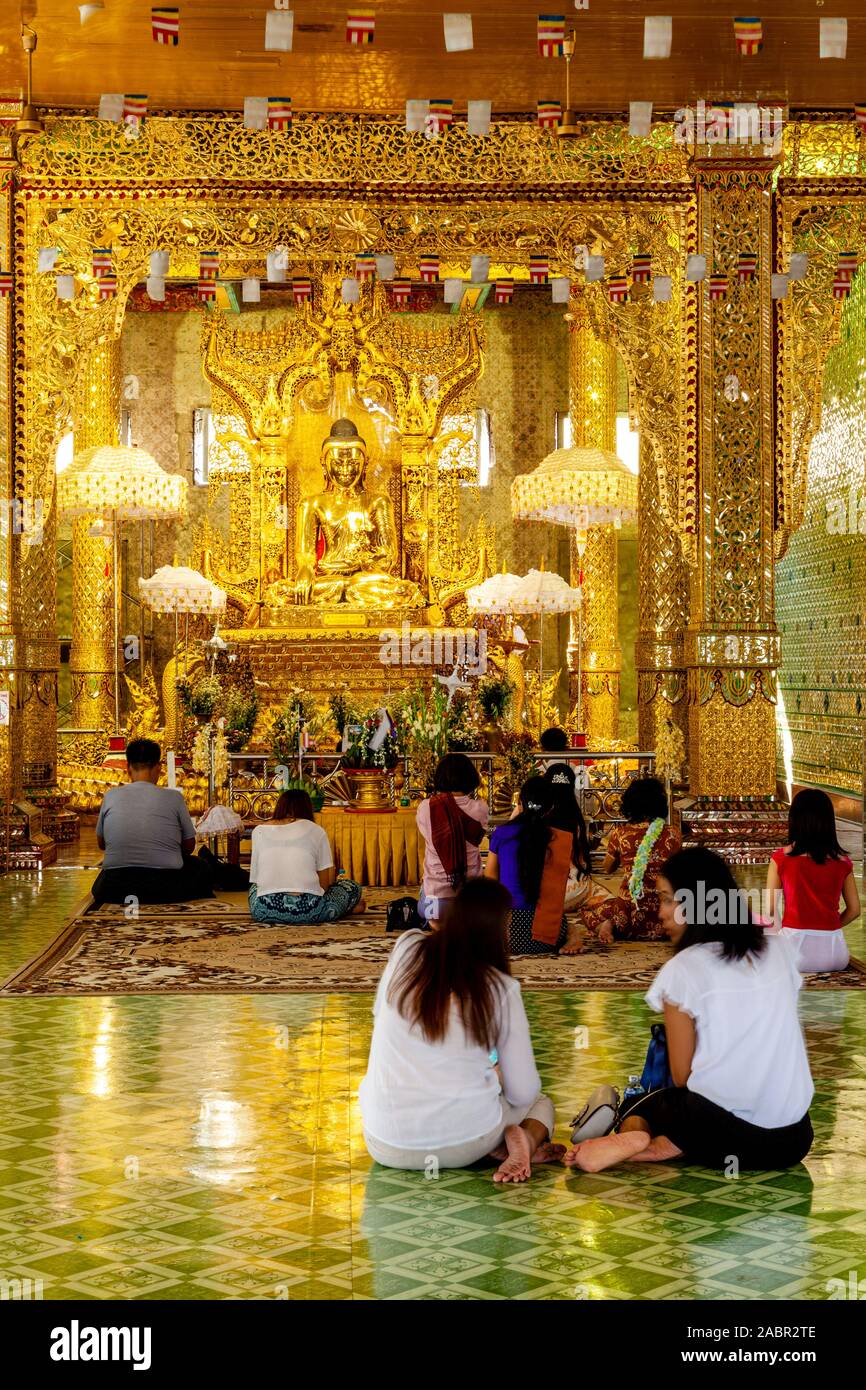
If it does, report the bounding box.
[767,787,860,974]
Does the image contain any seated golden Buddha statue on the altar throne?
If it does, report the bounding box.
[265,420,424,607]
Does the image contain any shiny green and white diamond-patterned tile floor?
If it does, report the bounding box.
[0,870,866,1300]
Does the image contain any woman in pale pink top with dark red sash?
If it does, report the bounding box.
[417,753,489,922]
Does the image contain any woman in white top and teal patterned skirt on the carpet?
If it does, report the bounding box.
[250,791,366,926]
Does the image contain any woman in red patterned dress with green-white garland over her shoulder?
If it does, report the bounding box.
[584,777,683,945]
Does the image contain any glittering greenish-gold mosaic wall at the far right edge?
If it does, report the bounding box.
[777,274,866,794]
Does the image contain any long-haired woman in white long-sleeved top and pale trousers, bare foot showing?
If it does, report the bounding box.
[359,878,564,1183]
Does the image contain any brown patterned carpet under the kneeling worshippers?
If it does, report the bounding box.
[0,888,866,995]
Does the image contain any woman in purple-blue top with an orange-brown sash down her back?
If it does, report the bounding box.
[484,777,589,955]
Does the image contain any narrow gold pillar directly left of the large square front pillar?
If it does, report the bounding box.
[635,435,688,749]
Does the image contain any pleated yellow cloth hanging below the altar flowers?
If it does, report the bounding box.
[316,806,424,888]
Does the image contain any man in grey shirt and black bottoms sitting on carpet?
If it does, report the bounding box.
[92,738,213,904]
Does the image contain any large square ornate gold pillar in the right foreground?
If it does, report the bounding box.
[685,152,778,796]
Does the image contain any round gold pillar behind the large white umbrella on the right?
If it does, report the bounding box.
[569,300,623,746]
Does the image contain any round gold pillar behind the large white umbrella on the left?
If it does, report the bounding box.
[70,338,120,730]
